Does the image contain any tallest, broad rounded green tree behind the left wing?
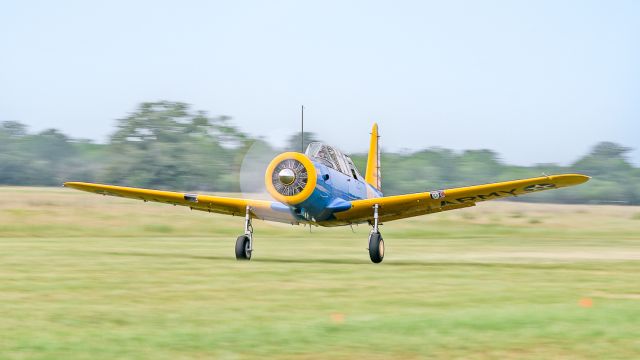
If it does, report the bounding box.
[102,101,247,191]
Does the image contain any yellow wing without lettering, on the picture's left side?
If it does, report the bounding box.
[64,182,299,224]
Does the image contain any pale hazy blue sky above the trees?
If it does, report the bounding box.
[0,0,640,164]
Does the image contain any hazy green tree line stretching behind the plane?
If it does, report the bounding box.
[0,101,640,205]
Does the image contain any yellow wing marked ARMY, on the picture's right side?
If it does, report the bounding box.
[334,174,590,223]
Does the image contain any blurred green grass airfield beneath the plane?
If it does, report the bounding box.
[0,187,640,359]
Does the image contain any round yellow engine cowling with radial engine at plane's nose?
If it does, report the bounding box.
[264,152,317,205]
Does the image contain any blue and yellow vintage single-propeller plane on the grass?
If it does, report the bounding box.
[64,124,589,263]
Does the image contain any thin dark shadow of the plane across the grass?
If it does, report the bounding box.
[87,251,575,269]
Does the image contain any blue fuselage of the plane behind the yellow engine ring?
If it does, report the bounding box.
[274,159,382,222]
